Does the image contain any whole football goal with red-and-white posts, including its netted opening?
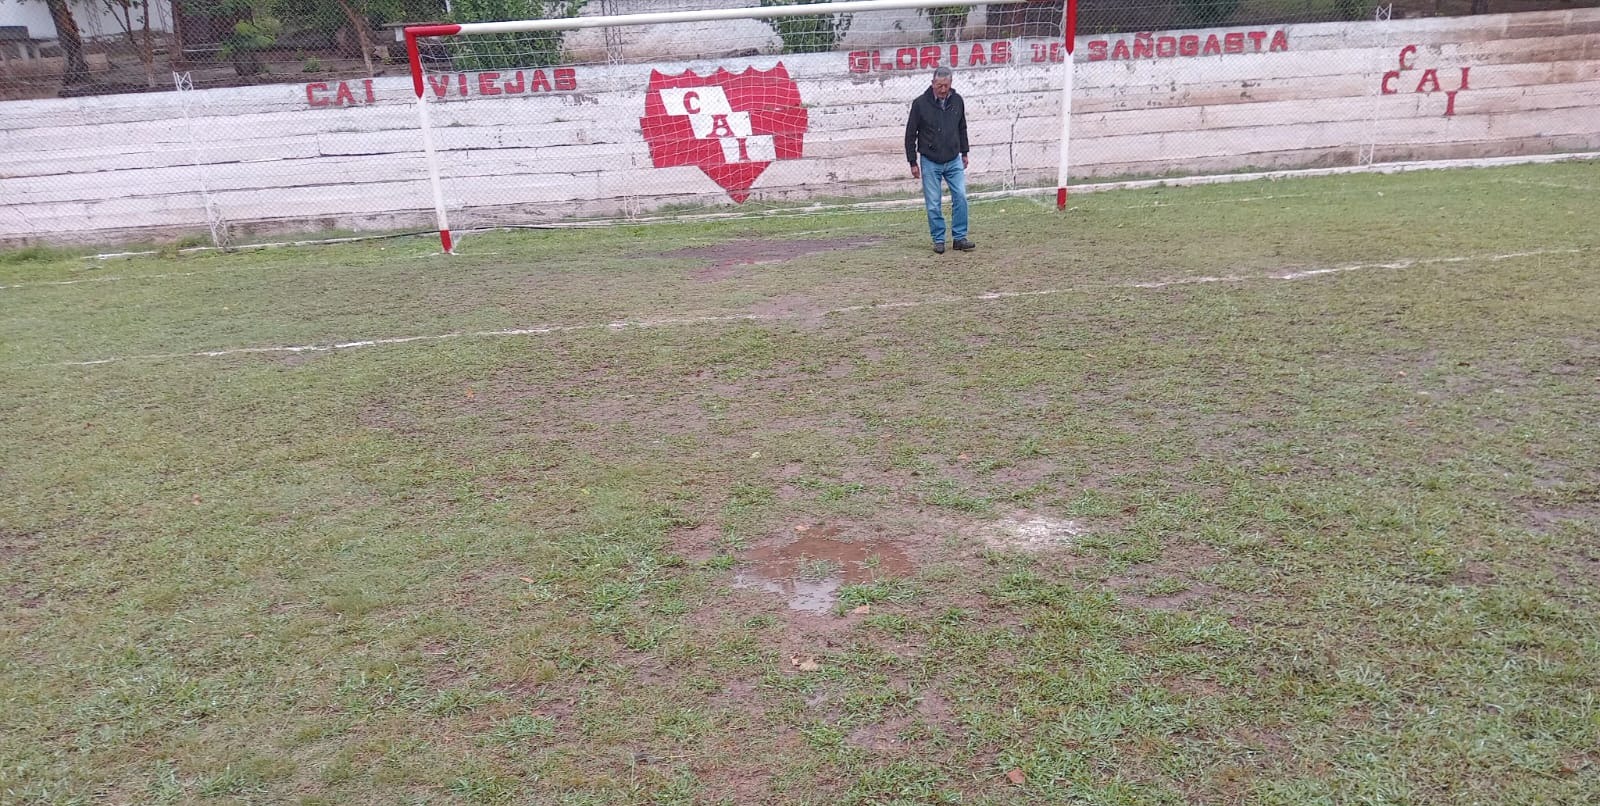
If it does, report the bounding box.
[405,0,1077,253]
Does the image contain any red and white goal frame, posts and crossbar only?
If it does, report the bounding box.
[405,0,1078,253]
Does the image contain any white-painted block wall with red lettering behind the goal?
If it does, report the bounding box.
[0,10,1600,243]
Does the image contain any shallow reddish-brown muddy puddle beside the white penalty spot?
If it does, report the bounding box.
[733,526,912,612]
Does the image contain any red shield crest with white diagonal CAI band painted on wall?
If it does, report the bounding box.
[638,62,808,203]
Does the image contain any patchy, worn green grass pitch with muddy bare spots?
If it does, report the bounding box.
[0,163,1600,804]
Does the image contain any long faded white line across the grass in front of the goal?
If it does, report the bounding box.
[58,248,1590,366]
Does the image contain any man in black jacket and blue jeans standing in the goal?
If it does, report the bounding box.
[906,67,976,254]
